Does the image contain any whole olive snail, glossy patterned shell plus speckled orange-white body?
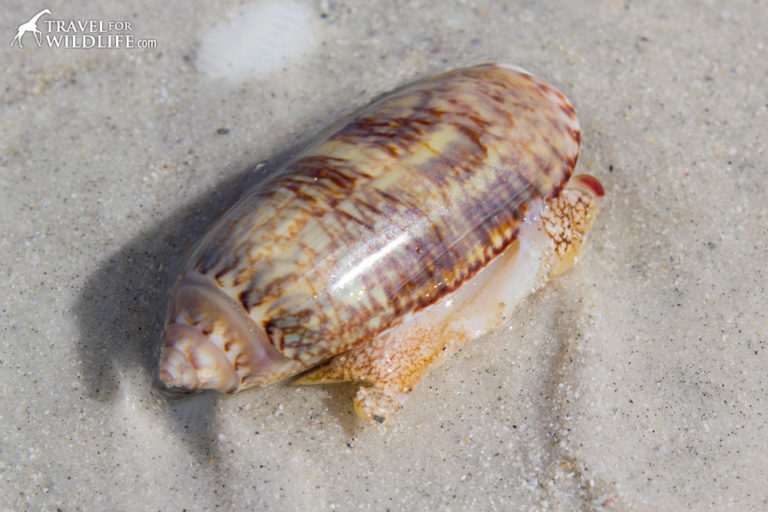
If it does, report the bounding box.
[159,64,603,423]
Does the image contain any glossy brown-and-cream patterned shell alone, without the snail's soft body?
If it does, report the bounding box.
[160,64,579,391]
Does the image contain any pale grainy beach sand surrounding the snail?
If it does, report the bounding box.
[0,0,768,511]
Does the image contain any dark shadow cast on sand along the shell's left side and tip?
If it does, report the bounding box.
[73,139,306,452]
